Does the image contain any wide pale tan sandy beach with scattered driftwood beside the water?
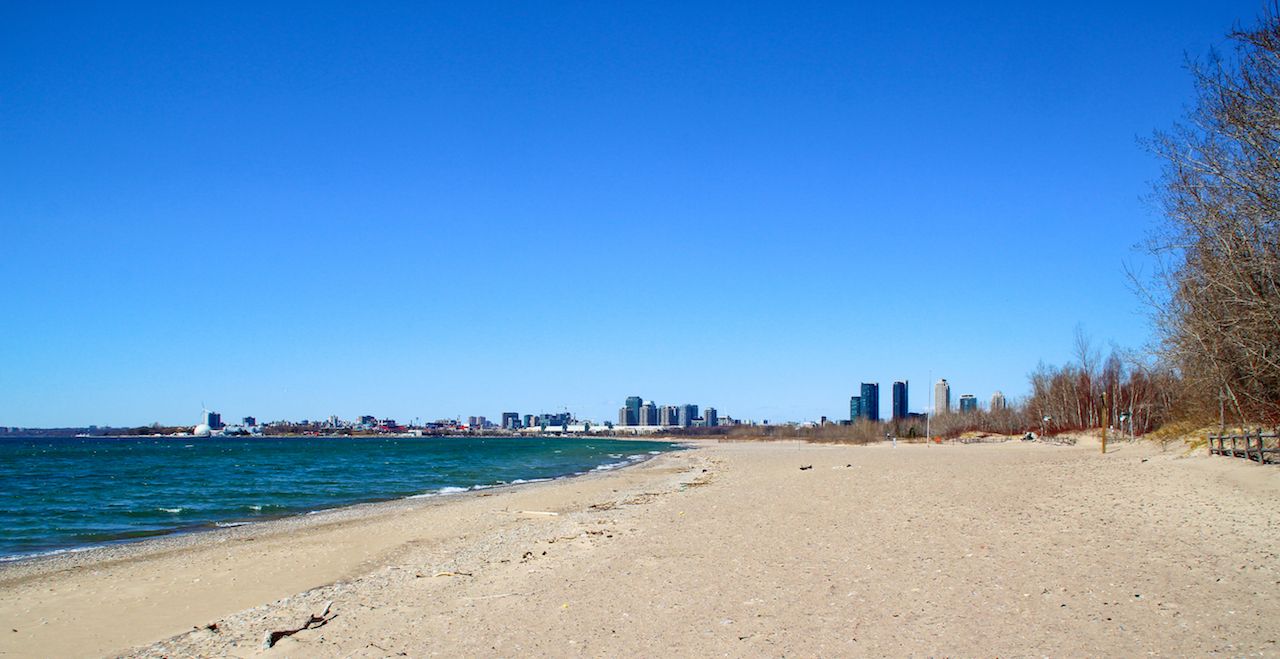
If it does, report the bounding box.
[0,441,1280,656]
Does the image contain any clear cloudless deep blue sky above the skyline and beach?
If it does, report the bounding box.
[0,0,1262,426]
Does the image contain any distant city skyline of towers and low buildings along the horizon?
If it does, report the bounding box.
[0,379,1007,436]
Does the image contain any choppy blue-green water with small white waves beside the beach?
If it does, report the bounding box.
[0,438,676,559]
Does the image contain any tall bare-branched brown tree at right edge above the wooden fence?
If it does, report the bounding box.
[1151,4,1280,424]
